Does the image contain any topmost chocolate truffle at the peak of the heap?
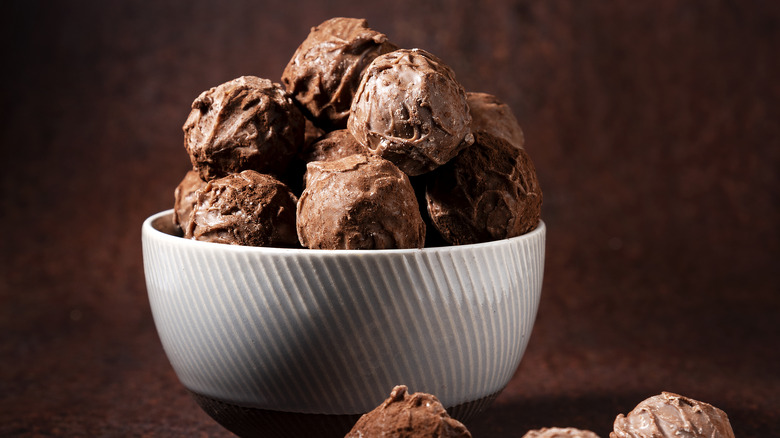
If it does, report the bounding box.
[282,17,398,131]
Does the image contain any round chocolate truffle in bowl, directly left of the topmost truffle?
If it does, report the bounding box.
[183,76,305,181]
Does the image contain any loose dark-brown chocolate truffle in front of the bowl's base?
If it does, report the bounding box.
[345,385,471,438]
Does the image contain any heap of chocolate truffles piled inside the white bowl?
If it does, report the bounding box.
[173,18,542,249]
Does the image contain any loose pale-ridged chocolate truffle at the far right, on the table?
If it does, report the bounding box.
[609,392,734,438]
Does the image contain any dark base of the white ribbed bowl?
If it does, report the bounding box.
[190,391,500,438]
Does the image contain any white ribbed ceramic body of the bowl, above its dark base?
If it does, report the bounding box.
[142,210,546,436]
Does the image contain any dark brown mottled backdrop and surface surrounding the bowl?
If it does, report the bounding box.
[0,0,780,438]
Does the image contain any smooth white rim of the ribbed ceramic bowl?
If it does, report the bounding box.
[141,209,546,257]
